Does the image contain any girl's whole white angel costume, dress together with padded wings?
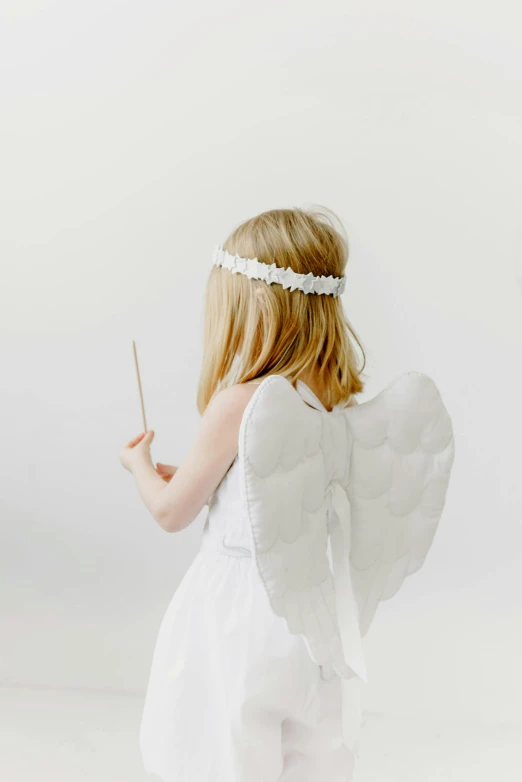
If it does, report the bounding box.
[140,370,454,782]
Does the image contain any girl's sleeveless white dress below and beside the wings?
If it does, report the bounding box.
[139,384,355,782]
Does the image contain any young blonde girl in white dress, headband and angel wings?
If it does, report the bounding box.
[120,209,453,782]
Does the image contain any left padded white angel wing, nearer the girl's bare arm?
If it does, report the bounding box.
[239,375,353,677]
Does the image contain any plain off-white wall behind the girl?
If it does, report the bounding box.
[0,0,522,782]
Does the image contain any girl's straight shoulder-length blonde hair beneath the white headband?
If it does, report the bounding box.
[197,207,366,414]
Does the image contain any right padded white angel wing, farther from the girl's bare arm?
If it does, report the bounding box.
[344,372,455,636]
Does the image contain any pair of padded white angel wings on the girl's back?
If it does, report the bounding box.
[239,372,454,660]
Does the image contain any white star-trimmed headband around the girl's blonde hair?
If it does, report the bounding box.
[212,245,346,297]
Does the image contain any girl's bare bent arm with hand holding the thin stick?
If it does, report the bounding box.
[126,384,256,532]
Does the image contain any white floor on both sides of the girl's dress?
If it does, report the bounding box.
[0,688,522,782]
